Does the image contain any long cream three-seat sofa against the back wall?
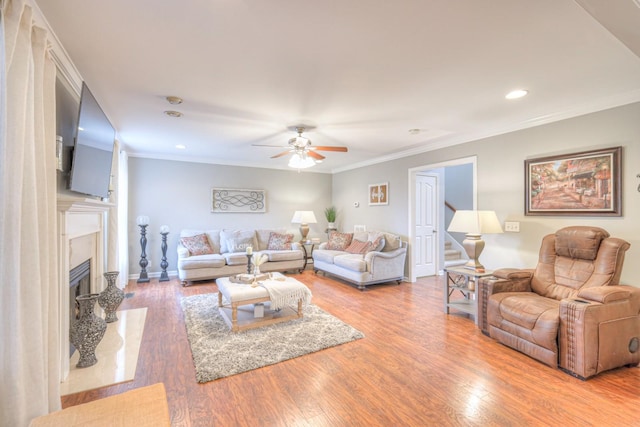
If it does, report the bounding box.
[177,230,305,286]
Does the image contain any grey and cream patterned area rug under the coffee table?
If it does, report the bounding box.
[181,294,364,383]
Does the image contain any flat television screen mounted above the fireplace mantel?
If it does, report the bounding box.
[69,82,116,198]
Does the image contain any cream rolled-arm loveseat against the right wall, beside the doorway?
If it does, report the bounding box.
[312,231,407,290]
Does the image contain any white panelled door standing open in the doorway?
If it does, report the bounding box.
[413,175,438,277]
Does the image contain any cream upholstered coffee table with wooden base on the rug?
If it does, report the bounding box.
[216,272,311,332]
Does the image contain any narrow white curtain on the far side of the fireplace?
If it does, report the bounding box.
[116,150,129,288]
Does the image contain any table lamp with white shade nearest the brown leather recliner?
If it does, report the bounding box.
[447,210,502,272]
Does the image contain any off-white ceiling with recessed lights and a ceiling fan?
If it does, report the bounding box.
[35,0,640,172]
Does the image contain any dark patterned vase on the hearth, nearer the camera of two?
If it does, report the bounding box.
[69,294,107,368]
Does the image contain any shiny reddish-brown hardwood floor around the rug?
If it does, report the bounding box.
[62,271,640,426]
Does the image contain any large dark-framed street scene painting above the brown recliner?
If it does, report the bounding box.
[524,147,622,216]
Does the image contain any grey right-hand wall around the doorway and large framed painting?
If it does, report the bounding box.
[333,103,640,286]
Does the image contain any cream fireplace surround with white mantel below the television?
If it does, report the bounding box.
[58,198,113,381]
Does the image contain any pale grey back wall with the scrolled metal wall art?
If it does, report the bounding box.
[128,157,331,277]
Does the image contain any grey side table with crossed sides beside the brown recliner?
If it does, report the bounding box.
[444,267,493,326]
